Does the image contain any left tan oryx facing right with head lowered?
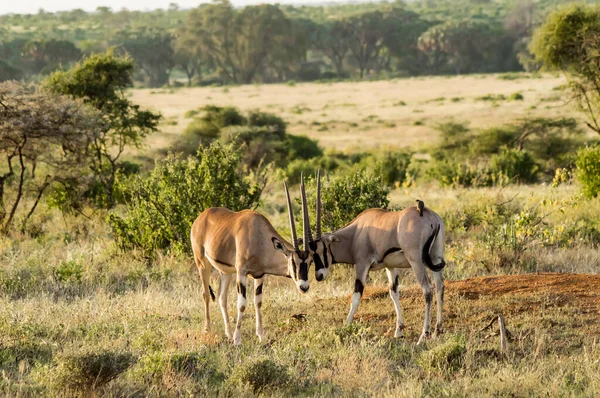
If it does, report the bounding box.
[190,183,312,345]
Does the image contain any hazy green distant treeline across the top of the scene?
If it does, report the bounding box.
[0,0,596,87]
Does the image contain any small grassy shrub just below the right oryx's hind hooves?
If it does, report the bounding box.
[419,336,467,375]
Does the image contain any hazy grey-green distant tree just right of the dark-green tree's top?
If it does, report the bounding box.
[123,31,175,87]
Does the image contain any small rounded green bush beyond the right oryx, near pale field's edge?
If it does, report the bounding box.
[490,149,539,184]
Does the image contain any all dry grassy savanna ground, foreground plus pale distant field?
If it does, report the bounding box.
[0,75,600,396]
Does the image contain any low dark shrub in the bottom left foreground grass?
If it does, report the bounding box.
[53,351,134,391]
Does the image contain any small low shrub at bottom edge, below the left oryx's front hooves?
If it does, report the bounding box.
[229,359,290,394]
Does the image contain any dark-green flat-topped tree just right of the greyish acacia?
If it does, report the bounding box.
[46,51,160,207]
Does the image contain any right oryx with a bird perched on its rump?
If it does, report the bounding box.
[308,174,445,344]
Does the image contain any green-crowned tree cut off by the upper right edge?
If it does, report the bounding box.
[531,6,600,134]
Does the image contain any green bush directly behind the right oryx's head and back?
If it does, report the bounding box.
[309,171,390,231]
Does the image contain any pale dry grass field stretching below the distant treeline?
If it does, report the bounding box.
[132,75,577,150]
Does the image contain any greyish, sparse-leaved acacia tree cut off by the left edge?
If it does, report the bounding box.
[0,82,101,234]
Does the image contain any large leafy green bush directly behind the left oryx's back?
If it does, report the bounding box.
[107,143,262,254]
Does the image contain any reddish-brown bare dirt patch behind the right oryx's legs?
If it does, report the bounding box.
[357,273,600,337]
